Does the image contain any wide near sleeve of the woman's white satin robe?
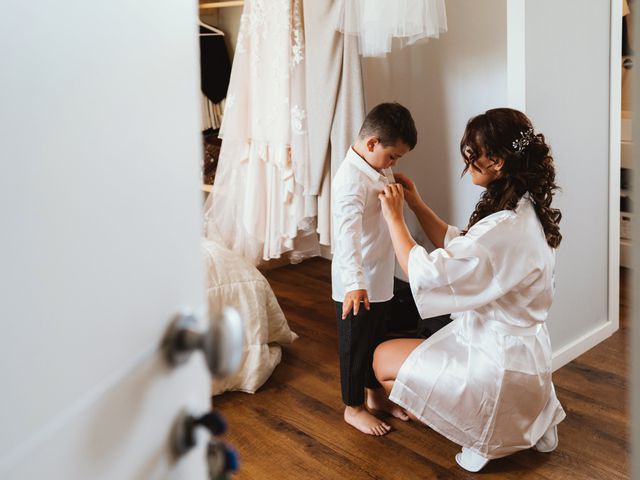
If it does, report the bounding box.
[409,214,536,318]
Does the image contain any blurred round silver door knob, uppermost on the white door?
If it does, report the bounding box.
[163,307,244,378]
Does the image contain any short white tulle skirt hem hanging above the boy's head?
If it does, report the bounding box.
[337,0,447,57]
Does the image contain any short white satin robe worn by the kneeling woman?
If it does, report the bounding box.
[390,195,565,458]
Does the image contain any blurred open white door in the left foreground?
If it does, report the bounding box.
[0,0,210,480]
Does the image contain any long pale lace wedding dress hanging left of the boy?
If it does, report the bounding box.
[204,0,319,264]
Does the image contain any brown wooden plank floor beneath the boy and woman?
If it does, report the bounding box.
[214,259,630,480]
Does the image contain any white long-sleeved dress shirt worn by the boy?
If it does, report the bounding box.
[331,147,395,302]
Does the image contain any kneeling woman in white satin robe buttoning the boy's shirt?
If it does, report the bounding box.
[374,108,565,471]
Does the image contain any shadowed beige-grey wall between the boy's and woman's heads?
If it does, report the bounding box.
[363,0,507,248]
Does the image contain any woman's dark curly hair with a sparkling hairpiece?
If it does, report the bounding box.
[460,108,562,248]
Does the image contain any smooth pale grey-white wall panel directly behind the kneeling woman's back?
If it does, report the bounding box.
[525,0,619,367]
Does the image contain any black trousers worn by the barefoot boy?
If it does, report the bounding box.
[335,301,391,406]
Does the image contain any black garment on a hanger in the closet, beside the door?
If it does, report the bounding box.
[200,27,231,103]
